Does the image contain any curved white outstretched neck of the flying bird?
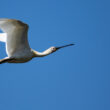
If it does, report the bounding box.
[32,48,52,57]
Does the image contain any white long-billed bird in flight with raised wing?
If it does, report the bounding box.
[0,19,74,64]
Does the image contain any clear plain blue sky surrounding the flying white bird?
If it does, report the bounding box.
[0,0,110,110]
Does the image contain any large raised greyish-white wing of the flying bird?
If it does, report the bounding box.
[0,19,30,57]
